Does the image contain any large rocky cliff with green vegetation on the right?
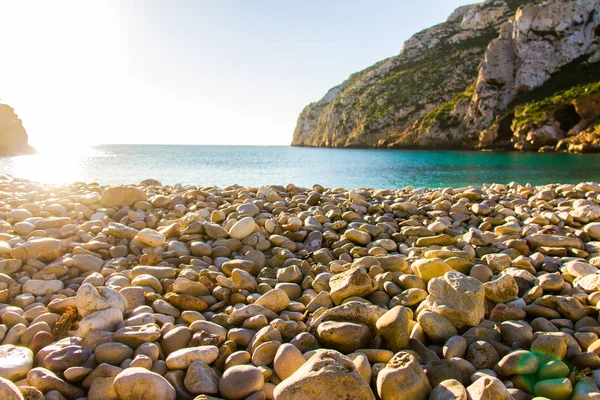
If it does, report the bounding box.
[292,0,600,151]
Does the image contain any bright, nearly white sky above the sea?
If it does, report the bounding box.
[0,0,476,148]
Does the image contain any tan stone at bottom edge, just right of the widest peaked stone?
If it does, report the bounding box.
[377,351,431,400]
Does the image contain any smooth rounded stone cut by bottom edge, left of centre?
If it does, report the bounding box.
[114,367,176,400]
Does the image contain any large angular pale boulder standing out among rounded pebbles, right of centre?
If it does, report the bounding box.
[426,272,485,329]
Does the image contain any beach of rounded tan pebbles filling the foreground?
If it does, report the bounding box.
[0,175,600,400]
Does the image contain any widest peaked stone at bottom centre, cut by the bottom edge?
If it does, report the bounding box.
[274,350,375,400]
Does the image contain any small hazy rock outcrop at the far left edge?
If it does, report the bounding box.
[0,104,35,156]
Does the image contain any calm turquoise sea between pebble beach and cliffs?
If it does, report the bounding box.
[0,145,600,189]
